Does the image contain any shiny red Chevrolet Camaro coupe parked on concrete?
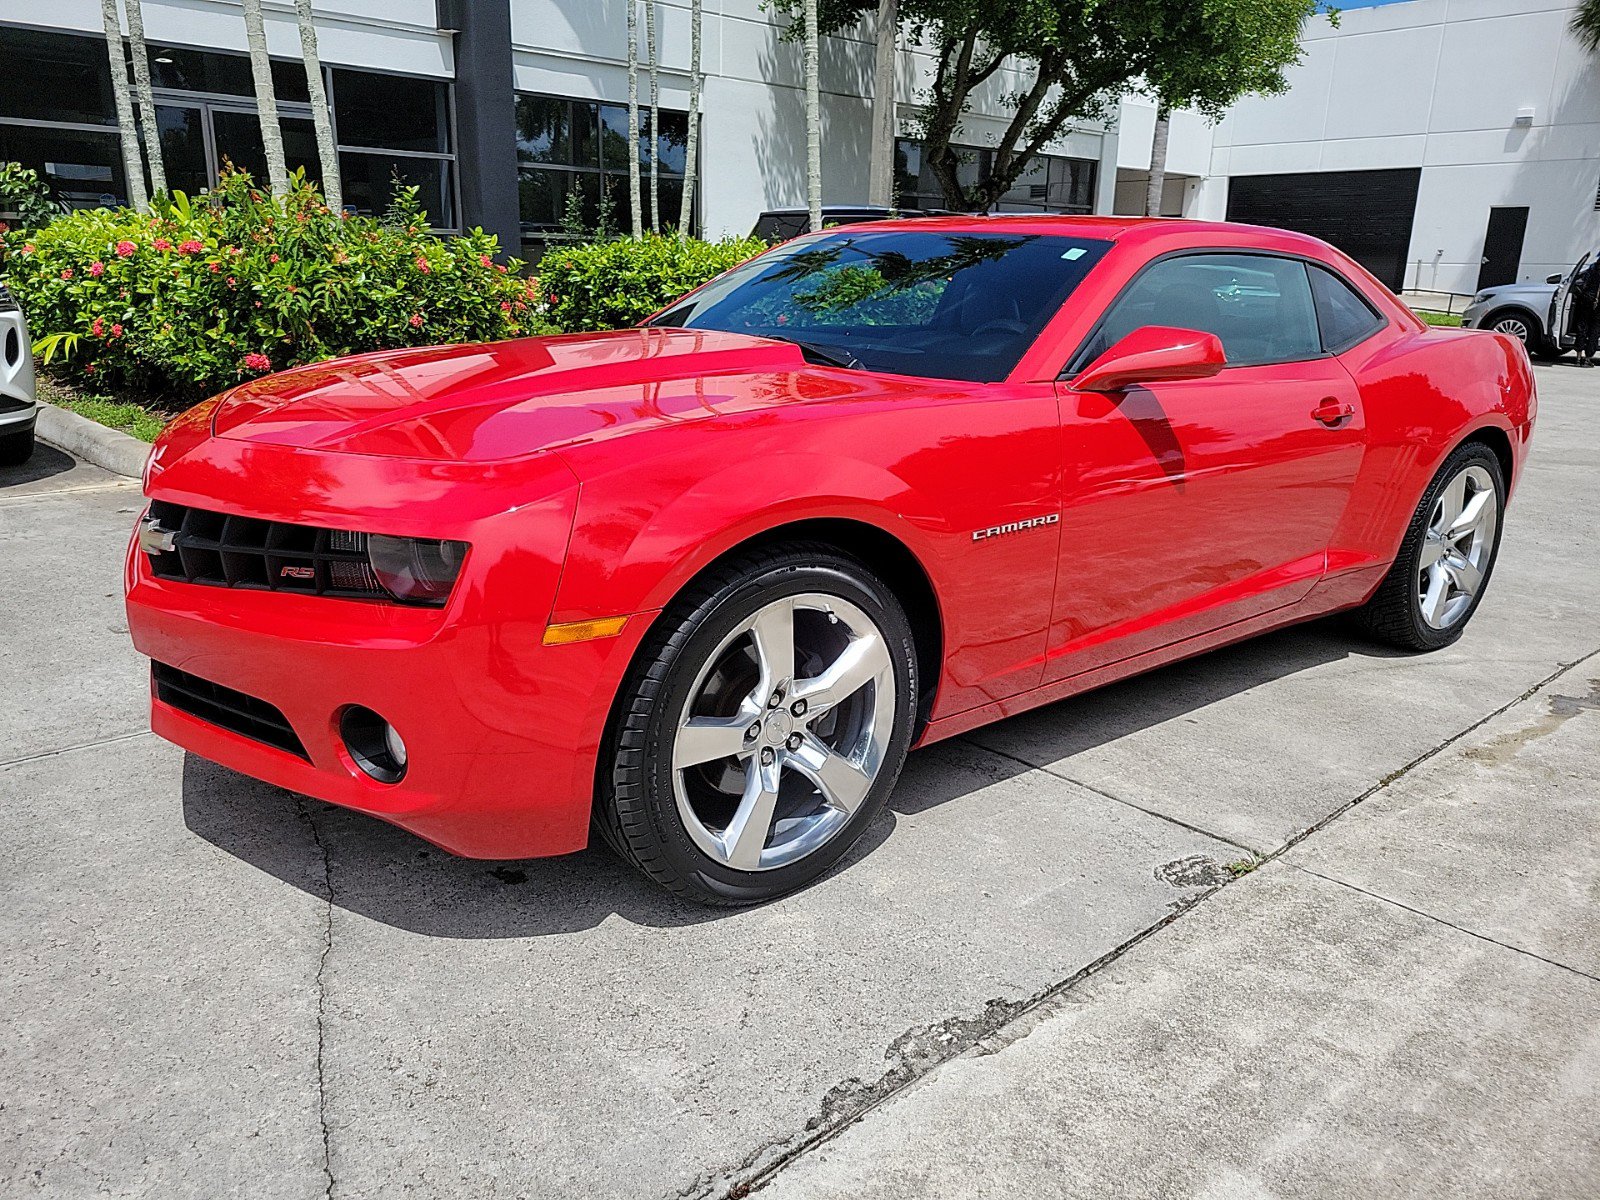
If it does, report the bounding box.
[126,218,1534,904]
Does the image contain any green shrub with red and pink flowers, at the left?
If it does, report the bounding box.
[5,173,546,398]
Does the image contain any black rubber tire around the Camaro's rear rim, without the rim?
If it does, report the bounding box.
[1354,442,1506,650]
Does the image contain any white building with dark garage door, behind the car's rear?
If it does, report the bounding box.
[1118,0,1600,293]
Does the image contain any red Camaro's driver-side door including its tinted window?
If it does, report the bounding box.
[1045,251,1366,682]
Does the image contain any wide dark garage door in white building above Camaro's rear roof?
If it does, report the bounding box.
[1227,166,1422,291]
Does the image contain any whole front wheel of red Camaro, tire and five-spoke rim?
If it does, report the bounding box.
[595,547,918,904]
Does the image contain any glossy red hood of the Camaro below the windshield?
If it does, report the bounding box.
[211,330,814,462]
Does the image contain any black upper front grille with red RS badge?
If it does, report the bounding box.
[149,501,394,602]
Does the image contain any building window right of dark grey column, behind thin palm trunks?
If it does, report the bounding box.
[517,94,690,253]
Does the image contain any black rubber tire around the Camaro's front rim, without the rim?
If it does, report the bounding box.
[594,544,918,906]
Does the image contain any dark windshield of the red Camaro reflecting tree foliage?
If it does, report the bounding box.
[650,230,1110,382]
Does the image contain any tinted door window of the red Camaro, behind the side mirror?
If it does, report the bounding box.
[1074,254,1322,370]
